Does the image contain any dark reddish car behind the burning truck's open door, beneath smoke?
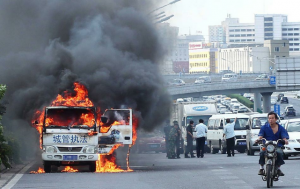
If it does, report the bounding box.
[134,133,166,153]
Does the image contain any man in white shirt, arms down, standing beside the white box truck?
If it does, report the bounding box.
[195,119,207,158]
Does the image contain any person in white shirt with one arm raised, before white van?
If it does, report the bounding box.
[223,118,236,157]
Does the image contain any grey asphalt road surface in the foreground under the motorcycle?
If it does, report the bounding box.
[7,153,300,189]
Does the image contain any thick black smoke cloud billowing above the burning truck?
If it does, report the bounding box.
[0,0,170,158]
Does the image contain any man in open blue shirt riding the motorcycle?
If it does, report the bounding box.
[256,112,289,176]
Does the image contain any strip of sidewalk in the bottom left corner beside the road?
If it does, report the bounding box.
[0,161,31,188]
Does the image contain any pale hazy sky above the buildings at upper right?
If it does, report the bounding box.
[156,0,300,39]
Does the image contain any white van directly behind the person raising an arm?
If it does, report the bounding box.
[207,114,249,154]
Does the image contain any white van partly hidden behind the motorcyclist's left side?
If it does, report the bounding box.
[246,113,268,156]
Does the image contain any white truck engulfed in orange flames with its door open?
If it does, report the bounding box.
[34,83,134,173]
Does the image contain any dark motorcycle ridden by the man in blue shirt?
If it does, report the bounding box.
[259,138,284,188]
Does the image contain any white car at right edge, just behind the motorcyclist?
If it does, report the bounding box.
[283,119,300,159]
